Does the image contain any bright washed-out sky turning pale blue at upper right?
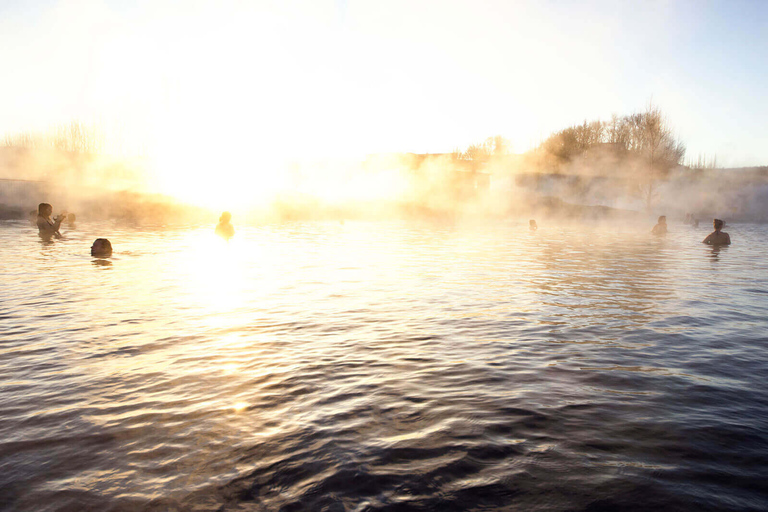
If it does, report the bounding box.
[0,0,768,166]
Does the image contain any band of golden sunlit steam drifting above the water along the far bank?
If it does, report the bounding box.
[0,140,768,223]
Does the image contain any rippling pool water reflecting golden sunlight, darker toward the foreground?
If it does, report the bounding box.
[0,222,768,511]
